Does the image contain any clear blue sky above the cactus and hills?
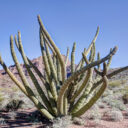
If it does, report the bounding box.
[0,0,128,68]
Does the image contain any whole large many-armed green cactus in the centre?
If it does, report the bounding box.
[0,16,128,120]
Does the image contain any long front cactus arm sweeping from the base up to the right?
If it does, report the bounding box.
[57,47,117,113]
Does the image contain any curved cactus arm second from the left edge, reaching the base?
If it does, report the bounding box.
[10,36,54,119]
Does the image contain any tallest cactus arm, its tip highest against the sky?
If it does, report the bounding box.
[38,15,66,82]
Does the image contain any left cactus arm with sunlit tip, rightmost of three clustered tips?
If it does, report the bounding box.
[18,32,52,112]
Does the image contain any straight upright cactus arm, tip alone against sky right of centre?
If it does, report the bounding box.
[71,42,76,73]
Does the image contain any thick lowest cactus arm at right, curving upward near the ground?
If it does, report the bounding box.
[72,76,108,117]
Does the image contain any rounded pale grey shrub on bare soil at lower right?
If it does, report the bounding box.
[105,110,123,122]
